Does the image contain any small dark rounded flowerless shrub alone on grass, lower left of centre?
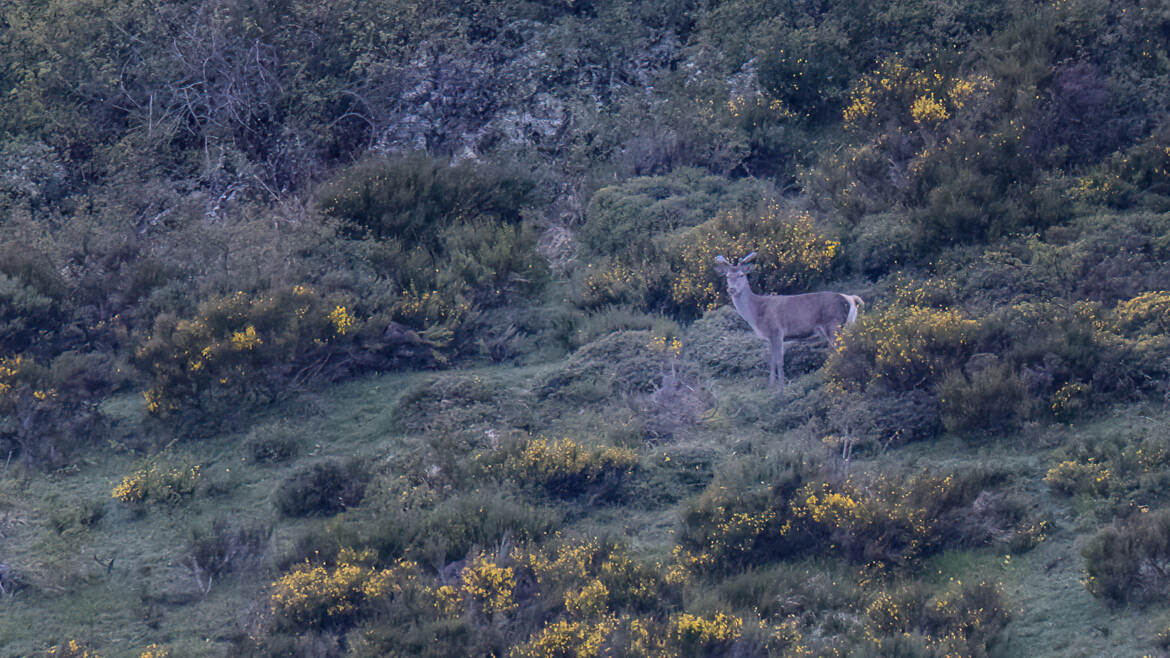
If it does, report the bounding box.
[273,460,370,516]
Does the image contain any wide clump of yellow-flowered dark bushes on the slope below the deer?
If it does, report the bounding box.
[674,449,998,580]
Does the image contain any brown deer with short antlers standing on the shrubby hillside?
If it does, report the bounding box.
[715,252,865,388]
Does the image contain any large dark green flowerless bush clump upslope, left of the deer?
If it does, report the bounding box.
[318,153,546,339]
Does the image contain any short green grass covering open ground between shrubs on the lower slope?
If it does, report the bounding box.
[0,365,1170,657]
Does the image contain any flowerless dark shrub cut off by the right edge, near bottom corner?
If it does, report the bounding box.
[1081,509,1170,603]
